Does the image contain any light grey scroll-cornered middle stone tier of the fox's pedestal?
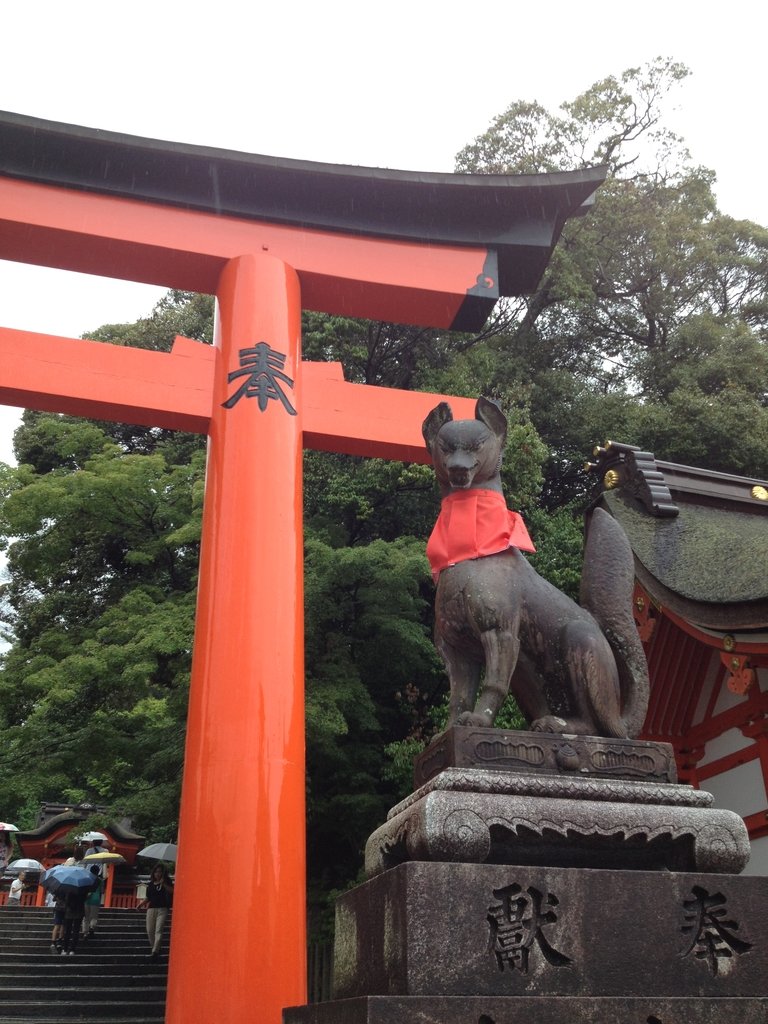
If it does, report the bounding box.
[366,768,750,878]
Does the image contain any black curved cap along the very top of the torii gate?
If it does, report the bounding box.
[0,112,606,296]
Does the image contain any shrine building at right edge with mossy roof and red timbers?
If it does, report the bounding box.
[589,441,768,874]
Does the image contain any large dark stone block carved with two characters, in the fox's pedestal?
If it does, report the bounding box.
[334,863,768,999]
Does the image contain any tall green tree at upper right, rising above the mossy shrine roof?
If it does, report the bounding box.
[457,58,768,499]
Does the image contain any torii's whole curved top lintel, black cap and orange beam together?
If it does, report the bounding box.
[0,112,606,331]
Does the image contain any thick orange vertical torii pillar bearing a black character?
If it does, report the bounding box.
[166,255,306,1024]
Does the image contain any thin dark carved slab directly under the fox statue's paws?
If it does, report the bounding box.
[414,725,677,790]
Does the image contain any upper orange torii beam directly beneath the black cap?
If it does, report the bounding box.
[0,178,487,328]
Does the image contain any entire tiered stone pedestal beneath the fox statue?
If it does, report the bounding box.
[284,729,768,1024]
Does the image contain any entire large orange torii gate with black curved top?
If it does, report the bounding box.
[0,108,605,1024]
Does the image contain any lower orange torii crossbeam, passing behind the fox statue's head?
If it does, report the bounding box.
[0,328,474,463]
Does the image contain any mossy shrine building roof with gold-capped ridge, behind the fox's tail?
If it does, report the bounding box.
[591,442,768,631]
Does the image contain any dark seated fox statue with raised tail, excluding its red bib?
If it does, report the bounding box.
[422,398,649,737]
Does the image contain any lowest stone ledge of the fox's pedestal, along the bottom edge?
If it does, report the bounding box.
[283,995,768,1024]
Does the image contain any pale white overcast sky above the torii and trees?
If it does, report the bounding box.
[0,0,768,460]
